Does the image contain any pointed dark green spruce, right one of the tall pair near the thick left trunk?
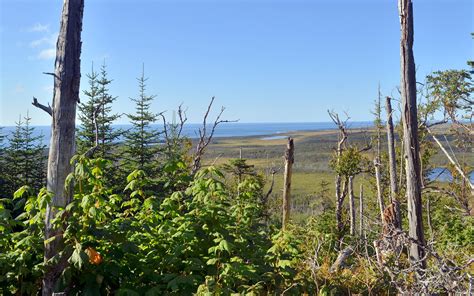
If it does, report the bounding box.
[125,70,159,176]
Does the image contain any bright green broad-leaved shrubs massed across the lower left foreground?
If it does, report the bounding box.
[0,155,308,295]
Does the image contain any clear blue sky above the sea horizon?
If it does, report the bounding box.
[0,0,474,125]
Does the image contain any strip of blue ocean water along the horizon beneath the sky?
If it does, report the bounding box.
[1,121,373,146]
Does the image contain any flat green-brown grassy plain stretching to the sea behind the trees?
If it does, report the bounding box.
[204,127,474,223]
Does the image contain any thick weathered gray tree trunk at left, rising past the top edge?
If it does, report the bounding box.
[42,0,84,296]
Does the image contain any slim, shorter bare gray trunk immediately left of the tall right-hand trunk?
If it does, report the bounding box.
[386,97,402,229]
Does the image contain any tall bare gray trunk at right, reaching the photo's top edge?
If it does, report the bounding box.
[398,0,426,268]
